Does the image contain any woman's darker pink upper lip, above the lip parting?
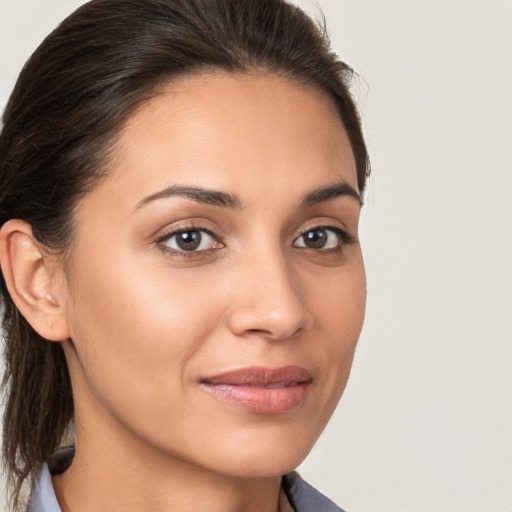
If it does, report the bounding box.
[202,366,311,386]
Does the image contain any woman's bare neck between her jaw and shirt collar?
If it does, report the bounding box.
[53,410,281,512]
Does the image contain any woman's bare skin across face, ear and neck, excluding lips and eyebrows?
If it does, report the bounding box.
[2,73,366,512]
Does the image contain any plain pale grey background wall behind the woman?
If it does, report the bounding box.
[0,0,512,512]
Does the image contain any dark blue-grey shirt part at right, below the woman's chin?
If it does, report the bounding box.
[283,471,345,512]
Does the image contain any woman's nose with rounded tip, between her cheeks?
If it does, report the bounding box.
[228,251,313,340]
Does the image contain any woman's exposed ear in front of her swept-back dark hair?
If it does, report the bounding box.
[0,219,69,341]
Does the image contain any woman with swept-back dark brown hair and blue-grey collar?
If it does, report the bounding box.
[0,0,368,512]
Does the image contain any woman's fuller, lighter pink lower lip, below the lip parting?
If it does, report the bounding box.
[203,382,311,414]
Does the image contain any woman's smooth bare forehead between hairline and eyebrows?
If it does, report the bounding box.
[85,73,357,214]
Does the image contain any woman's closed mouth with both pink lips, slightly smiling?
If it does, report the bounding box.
[201,366,312,414]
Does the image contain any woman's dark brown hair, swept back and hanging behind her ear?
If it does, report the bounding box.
[0,0,370,508]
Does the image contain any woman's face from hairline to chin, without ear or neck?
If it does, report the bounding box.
[59,74,366,476]
